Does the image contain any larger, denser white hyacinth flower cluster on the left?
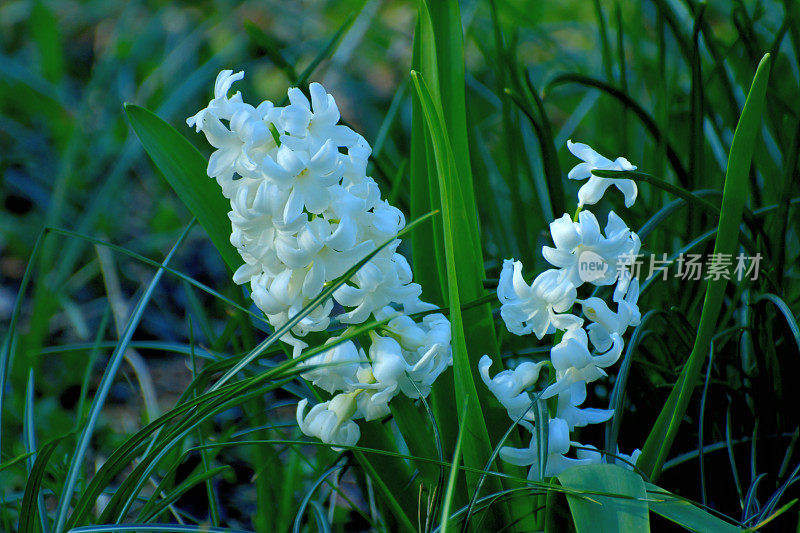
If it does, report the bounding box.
[187,70,452,446]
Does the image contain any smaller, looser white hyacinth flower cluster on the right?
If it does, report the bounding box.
[478,141,641,479]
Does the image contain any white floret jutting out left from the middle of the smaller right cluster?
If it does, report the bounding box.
[497,259,582,339]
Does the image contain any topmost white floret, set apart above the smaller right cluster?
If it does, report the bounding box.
[567,141,638,207]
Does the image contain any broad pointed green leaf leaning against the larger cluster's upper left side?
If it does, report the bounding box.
[125,104,242,271]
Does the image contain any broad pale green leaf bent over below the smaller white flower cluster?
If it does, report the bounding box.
[557,464,650,533]
